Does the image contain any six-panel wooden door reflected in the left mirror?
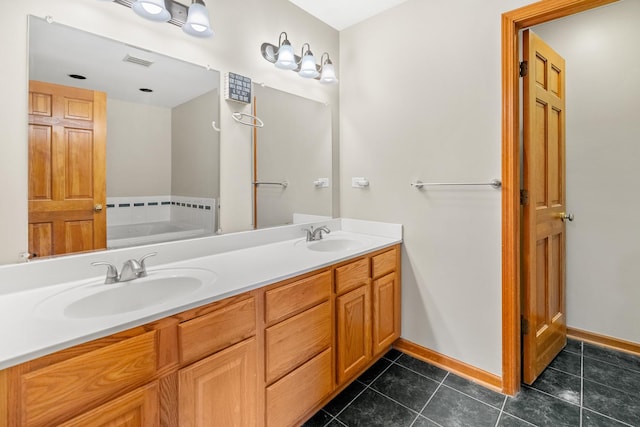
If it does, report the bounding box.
[29,81,107,256]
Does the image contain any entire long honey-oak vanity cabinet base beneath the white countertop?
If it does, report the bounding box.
[0,246,400,427]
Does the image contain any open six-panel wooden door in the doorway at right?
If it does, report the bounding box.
[522,30,567,384]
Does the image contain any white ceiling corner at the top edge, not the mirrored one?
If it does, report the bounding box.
[289,0,407,31]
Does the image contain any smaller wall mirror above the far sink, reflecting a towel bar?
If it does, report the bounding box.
[252,85,332,228]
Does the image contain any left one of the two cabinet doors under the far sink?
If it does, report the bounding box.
[336,284,371,384]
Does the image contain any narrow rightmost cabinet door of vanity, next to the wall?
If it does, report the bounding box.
[373,273,400,355]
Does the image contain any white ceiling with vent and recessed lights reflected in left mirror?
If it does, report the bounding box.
[29,17,219,108]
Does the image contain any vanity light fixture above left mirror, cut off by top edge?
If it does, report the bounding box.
[98,0,213,38]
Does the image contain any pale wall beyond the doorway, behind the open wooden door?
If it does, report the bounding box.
[534,0,640,343]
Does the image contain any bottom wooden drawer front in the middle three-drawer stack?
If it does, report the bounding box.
[267,348,333,427]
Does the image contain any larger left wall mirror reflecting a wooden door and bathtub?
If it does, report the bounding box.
[29,16,220,257]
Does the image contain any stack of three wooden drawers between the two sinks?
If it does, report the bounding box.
[265,269,334,427]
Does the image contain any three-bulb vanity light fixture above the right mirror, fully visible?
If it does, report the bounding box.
[260,31,338,84]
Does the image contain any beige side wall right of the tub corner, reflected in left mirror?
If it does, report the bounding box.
[171,90,220,198]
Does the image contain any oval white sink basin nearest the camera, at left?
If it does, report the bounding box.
[36,268,216,319]
